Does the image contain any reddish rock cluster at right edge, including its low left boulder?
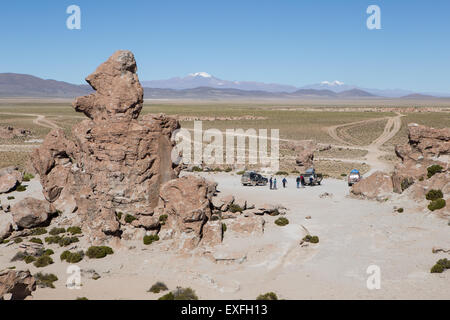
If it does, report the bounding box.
[352,123,450,212]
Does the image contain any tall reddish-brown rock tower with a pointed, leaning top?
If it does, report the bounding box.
[33,51,179,240]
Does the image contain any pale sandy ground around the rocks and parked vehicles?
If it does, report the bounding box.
[0,174,450,299]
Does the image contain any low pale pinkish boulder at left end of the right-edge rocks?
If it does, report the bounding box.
[351,171,394,201]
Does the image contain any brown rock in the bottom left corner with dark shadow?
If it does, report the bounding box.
[0,270,36,300]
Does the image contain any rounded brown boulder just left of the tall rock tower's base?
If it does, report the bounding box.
[11,197,56,228]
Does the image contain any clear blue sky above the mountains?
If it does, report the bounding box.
[0,0,450,92]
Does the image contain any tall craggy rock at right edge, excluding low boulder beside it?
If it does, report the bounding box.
[392,123,450,193]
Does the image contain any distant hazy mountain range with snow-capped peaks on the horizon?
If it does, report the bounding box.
[0,72,450,99]
